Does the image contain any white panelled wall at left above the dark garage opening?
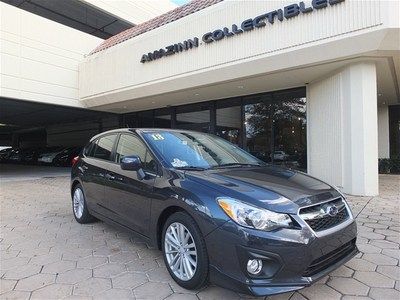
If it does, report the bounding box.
[0,2,102,107]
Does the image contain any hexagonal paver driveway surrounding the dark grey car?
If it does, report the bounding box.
[0,172,400,300]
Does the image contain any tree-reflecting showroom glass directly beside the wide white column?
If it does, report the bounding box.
[243,90,307,171]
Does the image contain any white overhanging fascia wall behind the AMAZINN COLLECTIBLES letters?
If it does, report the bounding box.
[80,0,399,107]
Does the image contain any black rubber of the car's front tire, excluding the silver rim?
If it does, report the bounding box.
[161,212,209,289]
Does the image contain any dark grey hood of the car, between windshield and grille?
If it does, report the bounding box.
[186,166,341,213]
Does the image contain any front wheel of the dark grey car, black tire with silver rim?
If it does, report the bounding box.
[162,212,209,289]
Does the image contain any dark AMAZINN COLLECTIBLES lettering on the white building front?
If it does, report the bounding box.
[140,0,345,63]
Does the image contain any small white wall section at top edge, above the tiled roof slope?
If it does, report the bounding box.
[81,0,177,24]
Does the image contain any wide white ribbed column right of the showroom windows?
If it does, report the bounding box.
[307,62,378,196]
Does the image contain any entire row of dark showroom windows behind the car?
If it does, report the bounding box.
[121,87,307,171]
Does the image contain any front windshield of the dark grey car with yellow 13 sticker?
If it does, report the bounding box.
[143,131,264,170]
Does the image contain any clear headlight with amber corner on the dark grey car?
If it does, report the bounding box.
[217,198,292,231]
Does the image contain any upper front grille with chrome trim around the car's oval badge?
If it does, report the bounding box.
[300,198,349,232]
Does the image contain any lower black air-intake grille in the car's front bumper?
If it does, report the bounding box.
[303,239,356,277]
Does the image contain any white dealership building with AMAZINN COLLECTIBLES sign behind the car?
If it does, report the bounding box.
[0,0,400,195]
